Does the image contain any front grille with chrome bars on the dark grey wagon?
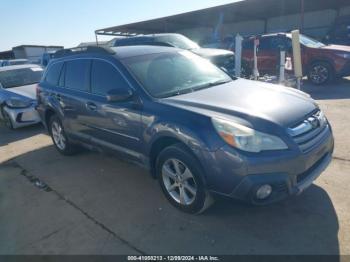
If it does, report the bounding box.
[288,111,330,153]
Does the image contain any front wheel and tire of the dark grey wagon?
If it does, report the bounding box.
[156,144,214,214]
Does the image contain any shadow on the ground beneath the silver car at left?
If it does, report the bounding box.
[0,121,45,147]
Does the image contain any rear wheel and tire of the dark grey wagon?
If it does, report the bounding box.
[49,115,78,156]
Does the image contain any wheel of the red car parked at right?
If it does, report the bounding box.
[308,62,335,85]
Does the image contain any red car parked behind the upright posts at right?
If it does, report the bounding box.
[242,33,350,85]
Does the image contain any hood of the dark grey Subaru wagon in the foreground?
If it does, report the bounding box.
[162,79,318,127]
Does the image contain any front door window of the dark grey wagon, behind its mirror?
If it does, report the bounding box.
[91,60,128,95]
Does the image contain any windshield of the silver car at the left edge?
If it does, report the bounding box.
[0,67,43,89]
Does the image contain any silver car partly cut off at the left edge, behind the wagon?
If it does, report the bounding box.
[0,64,43,129]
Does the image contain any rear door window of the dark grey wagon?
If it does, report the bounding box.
[65,59,91,91]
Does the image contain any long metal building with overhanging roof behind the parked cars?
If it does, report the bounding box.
[95,0,350,41]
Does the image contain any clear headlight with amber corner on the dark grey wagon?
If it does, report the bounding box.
[212,118,288,153]
